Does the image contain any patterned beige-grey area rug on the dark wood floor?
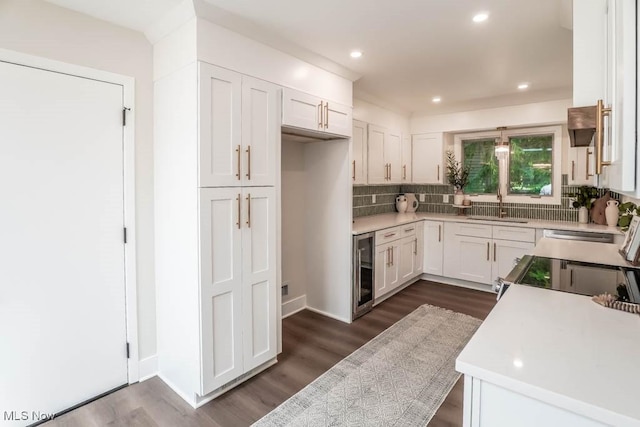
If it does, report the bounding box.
[253,305,481,427]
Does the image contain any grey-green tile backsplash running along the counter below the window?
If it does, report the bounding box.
[353,175,620,222]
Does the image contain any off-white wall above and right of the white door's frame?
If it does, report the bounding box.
[0,0,156,359]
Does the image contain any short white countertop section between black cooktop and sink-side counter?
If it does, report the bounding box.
[531,237,640,268]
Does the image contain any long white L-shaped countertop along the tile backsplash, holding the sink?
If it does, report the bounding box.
[351,212,621,234]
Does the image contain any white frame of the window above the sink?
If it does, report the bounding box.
[453,125,562,205]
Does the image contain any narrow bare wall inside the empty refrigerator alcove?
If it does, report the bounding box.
[281,140,308,302]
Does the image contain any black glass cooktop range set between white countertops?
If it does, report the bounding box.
[494,255,640,303]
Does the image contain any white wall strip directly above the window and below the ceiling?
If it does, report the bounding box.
[410,99,572,134]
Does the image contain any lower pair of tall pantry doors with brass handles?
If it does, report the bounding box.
[200,173,277,395]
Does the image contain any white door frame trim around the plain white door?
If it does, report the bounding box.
[0,49,140,384]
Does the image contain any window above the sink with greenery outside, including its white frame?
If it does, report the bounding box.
[454,126,561,204]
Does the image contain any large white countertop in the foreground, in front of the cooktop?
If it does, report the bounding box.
[456,285,640,426]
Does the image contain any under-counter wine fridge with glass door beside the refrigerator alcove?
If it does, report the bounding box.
[351,233,375,320]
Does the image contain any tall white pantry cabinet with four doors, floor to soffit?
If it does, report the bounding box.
[155,62,280,406]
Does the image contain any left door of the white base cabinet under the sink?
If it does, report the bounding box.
[453,236,492,284]
